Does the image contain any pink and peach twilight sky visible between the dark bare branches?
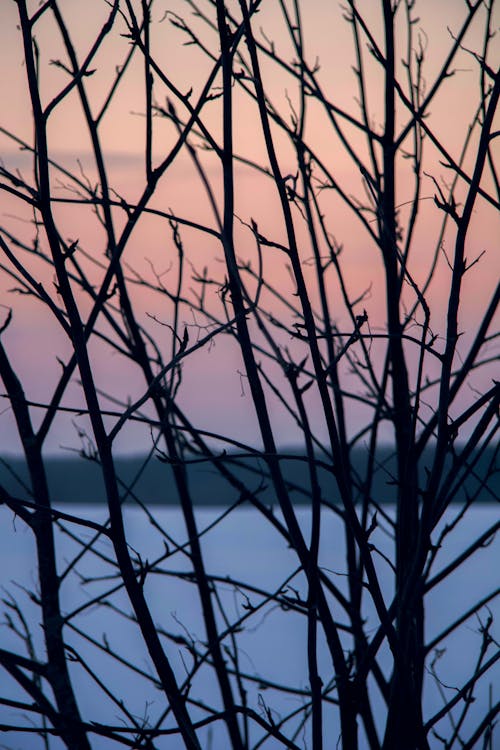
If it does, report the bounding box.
[0,0,500,452]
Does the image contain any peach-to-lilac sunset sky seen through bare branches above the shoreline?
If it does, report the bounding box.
[0,0,500,453]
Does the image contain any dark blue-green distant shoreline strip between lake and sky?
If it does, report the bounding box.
[0,446,500,507]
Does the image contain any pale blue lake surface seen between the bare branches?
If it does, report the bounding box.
[0,496,500,750]
